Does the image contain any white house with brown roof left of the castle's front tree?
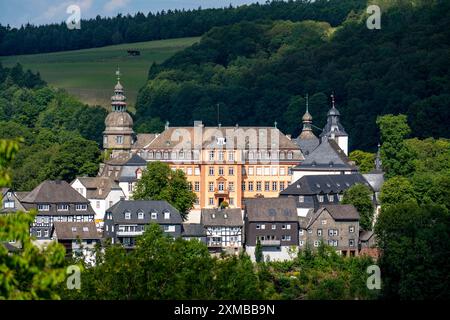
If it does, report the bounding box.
[70,177,125,227]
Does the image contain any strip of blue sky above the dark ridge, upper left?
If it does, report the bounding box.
[0,0,265,27]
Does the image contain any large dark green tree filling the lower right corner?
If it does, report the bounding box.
[376,203,450,300]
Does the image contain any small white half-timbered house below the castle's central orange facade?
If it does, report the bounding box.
[201,208,244,254]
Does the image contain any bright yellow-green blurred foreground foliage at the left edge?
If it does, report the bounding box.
[0,139,65,300]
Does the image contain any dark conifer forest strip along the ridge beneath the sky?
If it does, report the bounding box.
[0,0,367,55]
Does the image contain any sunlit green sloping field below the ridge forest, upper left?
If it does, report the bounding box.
[0,38,199,110]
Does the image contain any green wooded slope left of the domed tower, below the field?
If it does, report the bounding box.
[0,64,106,191]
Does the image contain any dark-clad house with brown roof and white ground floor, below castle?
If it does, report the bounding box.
[244,197,298,260]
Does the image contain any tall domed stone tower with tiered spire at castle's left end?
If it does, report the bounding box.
[103,69,134,155]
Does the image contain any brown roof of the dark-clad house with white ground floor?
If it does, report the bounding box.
[245,197,298,222]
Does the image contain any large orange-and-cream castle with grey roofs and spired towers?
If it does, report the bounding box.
[99,70,357,219]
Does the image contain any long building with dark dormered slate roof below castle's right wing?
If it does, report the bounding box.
[280,173,372,217]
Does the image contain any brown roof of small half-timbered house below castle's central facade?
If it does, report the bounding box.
[200,209,244,227]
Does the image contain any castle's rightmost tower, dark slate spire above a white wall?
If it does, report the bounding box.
[320,94,348,155]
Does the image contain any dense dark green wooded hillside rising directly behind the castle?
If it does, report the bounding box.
[135,1,450,150]
